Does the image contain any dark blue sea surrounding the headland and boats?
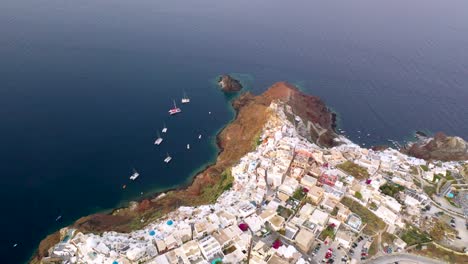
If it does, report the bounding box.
[0,0,468,263]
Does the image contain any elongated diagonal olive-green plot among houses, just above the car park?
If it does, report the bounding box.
[341,197,385,235]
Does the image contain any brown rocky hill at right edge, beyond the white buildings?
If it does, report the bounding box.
[404,132,468,161]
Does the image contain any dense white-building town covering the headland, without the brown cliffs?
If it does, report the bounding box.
[43,102,468,264]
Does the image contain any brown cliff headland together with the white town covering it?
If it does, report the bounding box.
[31,80,468,264]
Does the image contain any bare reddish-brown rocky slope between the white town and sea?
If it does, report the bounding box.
[31,82,339,263]
